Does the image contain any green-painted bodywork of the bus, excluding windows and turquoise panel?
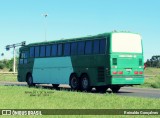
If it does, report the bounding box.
[18,33,144,87]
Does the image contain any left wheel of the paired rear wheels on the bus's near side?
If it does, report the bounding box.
[70,74,80,90]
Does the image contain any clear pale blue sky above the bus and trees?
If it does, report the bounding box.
[0,0,160,60]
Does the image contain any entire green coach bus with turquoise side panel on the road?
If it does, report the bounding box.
[18,32,144,92]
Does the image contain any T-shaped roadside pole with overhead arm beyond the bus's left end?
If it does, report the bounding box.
[6,41,26,73]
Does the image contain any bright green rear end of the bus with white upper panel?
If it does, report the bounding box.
[110,33,144,89]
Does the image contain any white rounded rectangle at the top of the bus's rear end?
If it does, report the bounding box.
[112,33,142,53]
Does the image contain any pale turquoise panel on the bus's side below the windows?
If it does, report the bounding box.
[32,57,73,84]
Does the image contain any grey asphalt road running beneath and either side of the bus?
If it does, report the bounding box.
[0,82,160,98]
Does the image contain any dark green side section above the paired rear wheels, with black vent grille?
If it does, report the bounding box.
[71,55,109,86]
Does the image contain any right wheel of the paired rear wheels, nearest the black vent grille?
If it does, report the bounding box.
[81,74,92,92]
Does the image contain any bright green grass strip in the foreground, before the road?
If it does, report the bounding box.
[0,86,160,118]
